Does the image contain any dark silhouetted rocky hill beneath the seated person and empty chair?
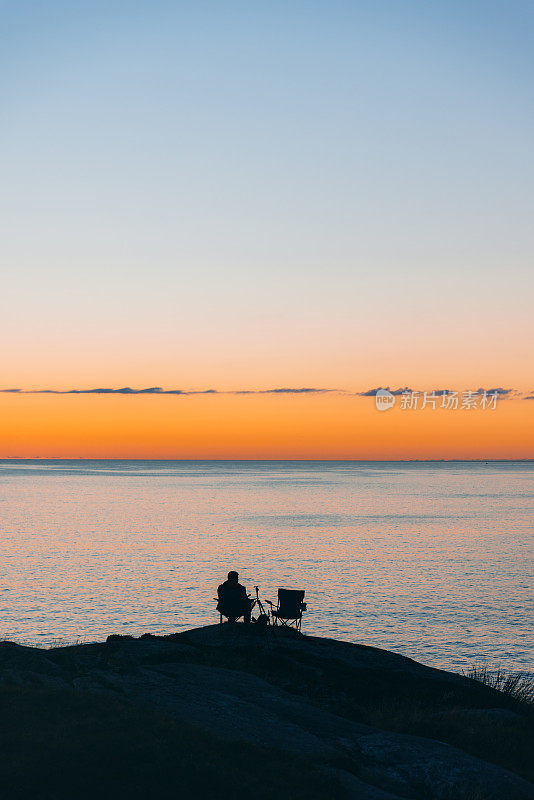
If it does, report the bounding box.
[0,624,534,800]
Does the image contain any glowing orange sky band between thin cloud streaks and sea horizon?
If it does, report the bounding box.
[0,394,534,460]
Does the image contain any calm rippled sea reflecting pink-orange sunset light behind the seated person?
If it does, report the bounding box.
[0,460,534,671]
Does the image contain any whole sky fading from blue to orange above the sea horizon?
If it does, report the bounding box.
[0,0,534,458]
